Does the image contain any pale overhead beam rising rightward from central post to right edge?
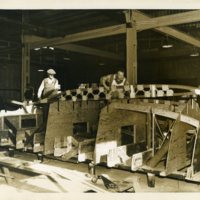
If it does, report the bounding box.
[136,10,200,31]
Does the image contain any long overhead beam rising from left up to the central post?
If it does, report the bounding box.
[29,24,126,48]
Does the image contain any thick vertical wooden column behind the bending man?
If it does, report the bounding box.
[125,10,137,85]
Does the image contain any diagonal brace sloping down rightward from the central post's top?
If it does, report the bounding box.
[135,11,200,47]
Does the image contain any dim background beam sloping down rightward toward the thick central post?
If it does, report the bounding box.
[54,44,125,61]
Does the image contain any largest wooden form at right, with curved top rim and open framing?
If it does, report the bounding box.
[94,98,200,182]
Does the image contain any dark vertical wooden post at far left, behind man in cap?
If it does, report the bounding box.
[21,14,30,101]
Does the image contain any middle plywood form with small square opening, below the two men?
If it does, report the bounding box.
[44,101,101,155]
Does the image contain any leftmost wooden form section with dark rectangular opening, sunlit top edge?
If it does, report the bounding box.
[0,109,43,151]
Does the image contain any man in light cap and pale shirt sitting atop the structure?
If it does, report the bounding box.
[38,69,60,99]
